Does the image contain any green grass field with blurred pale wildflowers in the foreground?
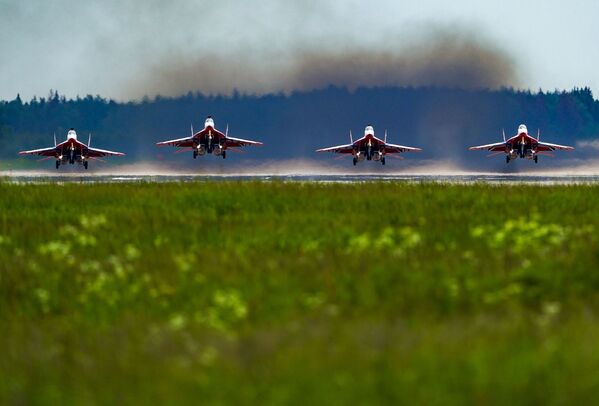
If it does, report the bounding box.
[0,182,599,404]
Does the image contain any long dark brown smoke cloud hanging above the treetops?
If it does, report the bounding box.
[127,27,520,97]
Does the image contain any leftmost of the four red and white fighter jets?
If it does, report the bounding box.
[19,128,125,169]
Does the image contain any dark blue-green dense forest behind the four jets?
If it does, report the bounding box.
[0,87,599,164]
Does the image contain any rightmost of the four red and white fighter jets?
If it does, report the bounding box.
[469,124,574,163]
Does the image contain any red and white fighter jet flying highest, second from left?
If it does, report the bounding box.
[156,116,263,159]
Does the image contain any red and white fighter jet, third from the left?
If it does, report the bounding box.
[316,125,422,165]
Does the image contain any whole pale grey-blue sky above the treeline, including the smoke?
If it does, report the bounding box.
[0,0,599,100]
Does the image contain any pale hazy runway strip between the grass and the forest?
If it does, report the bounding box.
[0,160,599,185]
